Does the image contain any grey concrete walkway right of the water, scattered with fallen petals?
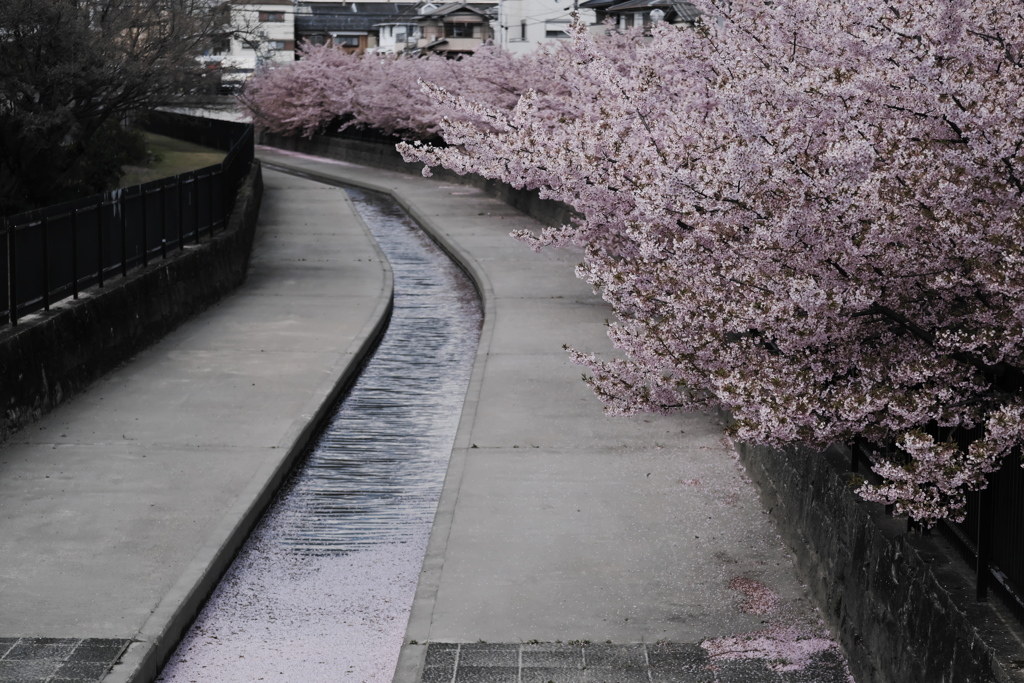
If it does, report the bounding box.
[258,148,847,683]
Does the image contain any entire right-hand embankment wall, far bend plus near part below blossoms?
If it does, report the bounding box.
[261,134,1024,683]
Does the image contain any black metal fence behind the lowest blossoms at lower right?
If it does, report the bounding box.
[852,432,1024,622]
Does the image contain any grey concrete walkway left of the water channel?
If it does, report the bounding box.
[0,171,392,683]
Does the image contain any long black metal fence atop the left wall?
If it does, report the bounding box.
[0,115,254,326]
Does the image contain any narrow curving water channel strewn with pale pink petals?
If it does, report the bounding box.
[158,184,481,683]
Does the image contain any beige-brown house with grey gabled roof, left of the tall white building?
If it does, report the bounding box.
[416,0,496,56]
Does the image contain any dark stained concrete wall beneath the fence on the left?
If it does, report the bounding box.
[0,162,263,440]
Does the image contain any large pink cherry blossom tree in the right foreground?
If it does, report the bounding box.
[399,0,1024,523]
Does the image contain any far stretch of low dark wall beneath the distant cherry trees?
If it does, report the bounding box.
[257,133,573,225]
